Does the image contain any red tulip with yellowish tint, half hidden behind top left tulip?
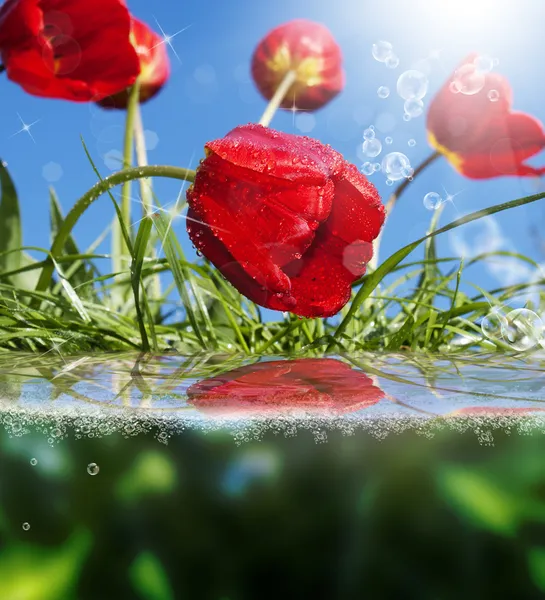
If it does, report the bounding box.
[98,17,170,108]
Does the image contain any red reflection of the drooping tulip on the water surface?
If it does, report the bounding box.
[187,358,384,417]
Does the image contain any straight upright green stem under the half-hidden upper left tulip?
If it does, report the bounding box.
[112,81,140,304]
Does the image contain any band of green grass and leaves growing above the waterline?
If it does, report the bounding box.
[0,157,545,355]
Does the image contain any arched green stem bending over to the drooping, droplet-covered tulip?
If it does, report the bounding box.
[36,165,195,291]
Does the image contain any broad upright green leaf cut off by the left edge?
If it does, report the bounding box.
[0,160,23,272]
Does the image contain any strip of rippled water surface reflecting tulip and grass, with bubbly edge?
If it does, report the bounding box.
[0,353,545,443]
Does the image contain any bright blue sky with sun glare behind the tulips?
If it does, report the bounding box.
[0,0,545,310]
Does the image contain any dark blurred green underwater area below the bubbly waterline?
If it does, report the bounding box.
[0,430,545,600]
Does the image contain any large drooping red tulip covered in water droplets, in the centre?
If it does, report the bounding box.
[187,124,384,317]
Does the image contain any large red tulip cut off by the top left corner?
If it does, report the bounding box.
[0,0,140,102]
